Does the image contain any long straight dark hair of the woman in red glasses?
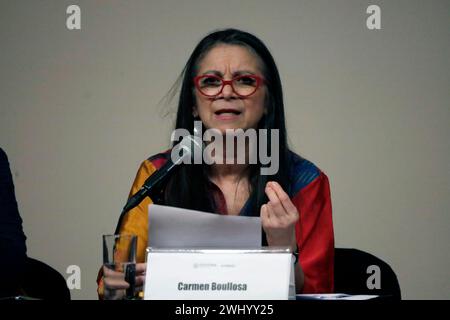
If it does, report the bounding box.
[164,29,290,216]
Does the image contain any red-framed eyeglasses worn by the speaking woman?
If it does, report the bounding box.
[194,74,264,98]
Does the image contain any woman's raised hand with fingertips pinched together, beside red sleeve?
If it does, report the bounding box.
[261,181,299,251]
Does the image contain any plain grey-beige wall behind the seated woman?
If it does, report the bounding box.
[0,0,450,299]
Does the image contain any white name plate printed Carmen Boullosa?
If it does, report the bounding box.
[144,248,295,300]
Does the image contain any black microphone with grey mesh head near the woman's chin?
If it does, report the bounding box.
[115,135,203,234]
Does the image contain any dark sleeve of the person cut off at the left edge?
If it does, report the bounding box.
[0,148,27,295]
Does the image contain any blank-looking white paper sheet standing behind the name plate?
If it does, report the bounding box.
[148,204,262,249]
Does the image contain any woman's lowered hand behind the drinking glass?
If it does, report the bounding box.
[103,263,147,300]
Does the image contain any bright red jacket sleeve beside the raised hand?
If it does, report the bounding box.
[292,172,334,293]
